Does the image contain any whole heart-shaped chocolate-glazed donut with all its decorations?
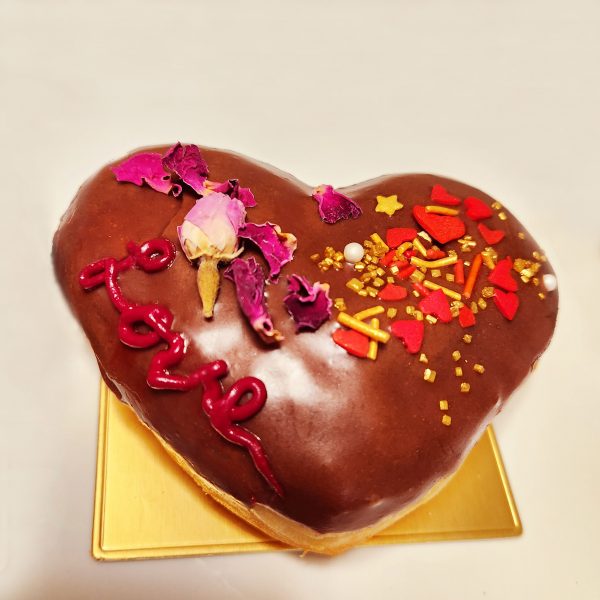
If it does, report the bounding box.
[53,144,558,553]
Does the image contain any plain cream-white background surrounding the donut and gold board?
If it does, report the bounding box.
[0,0,600,600]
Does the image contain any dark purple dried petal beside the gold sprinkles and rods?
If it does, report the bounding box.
[283,275,332,331]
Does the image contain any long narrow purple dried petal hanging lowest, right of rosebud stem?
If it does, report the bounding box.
[224,258,283,343]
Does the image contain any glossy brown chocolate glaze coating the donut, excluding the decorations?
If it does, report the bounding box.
[53,148,558,532]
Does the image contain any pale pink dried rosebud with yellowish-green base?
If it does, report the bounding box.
[177,193,246,318]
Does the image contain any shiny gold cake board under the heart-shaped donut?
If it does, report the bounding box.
[92,382,522,560]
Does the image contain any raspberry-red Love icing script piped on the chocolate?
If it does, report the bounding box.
[79,238,283,496]
